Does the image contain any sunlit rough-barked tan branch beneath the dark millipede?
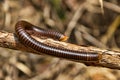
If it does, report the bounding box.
[0,31,120,69]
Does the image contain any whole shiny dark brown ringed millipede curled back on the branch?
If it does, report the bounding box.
[15,21,102,62]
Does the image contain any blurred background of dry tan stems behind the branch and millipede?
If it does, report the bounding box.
[0,0,120,80]
